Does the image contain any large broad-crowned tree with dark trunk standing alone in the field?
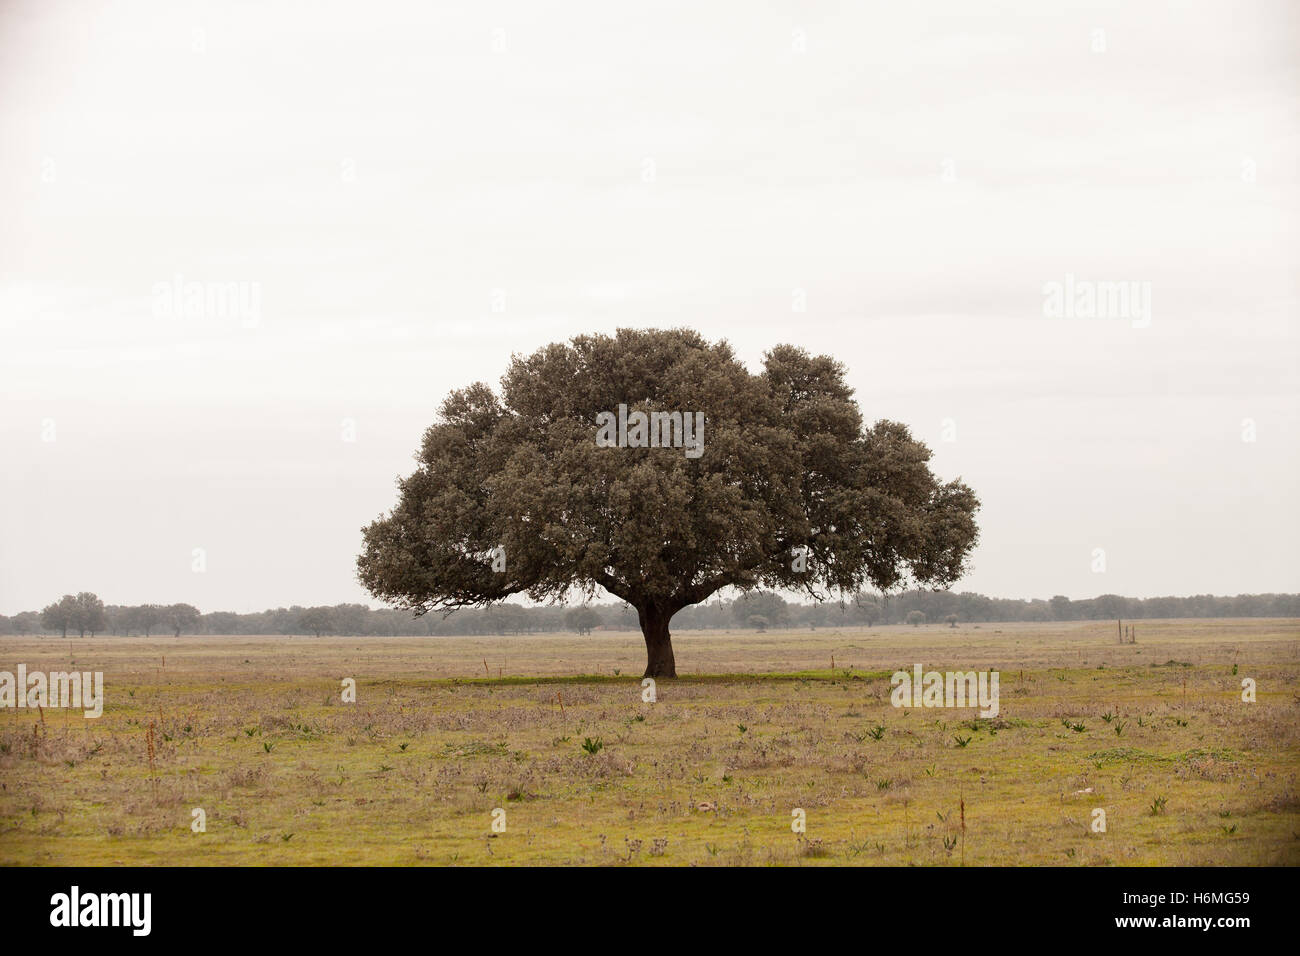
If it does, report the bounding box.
[358,329,979,678]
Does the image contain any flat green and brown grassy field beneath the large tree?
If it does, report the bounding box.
[0,620,1300,866]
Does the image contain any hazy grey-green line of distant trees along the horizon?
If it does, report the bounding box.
[0,591,1300,637]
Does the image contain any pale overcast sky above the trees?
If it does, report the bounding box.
[0,0,1300,614]
